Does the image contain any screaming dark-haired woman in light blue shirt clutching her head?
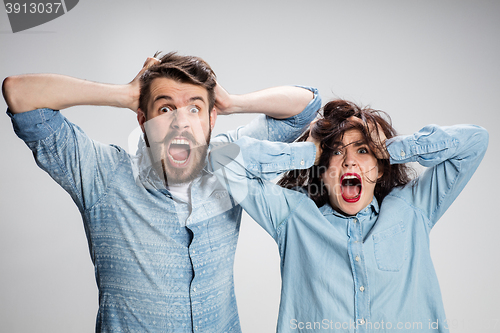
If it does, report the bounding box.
[210,100,488,332]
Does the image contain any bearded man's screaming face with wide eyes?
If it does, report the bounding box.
[137,78,217,185]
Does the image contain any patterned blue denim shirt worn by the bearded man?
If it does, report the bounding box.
[9,88,321,333]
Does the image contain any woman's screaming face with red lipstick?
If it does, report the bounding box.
[321,129,383,215]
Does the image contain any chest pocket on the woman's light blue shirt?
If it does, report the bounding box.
[373,222,408,272]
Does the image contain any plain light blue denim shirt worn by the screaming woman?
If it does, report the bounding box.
[210,125,488,332]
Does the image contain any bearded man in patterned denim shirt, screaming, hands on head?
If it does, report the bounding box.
[3,53,321,332]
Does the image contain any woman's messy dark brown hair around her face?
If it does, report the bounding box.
[278,99,413,207]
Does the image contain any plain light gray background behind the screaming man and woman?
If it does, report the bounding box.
[0,0,500,332]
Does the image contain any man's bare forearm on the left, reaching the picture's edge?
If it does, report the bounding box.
[2,74,137,113]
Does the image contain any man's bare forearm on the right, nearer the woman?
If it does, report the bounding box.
[218,86,314,119]
